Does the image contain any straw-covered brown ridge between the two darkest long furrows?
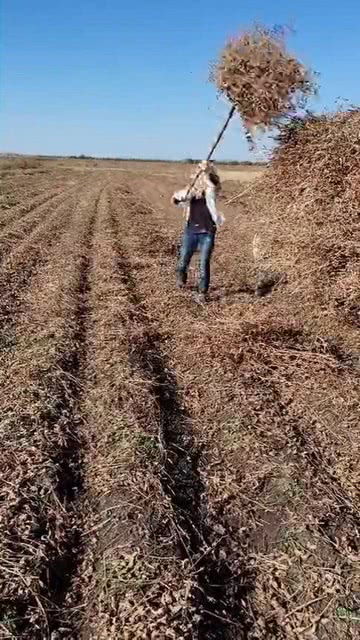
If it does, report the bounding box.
[78,191,174,638]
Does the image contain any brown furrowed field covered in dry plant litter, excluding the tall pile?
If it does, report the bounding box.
[0,160,360,640]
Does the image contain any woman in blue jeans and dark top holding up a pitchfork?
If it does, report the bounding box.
[172,161,224,302]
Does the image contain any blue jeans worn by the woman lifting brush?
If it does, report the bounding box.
[177,228,215,293]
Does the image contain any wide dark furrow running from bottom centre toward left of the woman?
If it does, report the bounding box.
[112,193,252,640]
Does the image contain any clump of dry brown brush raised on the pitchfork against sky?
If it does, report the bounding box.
[210,26,317,136]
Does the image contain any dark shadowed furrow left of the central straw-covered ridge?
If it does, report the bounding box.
[41,188,101,634]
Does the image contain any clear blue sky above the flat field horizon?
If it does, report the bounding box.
[0,0,360,159]
